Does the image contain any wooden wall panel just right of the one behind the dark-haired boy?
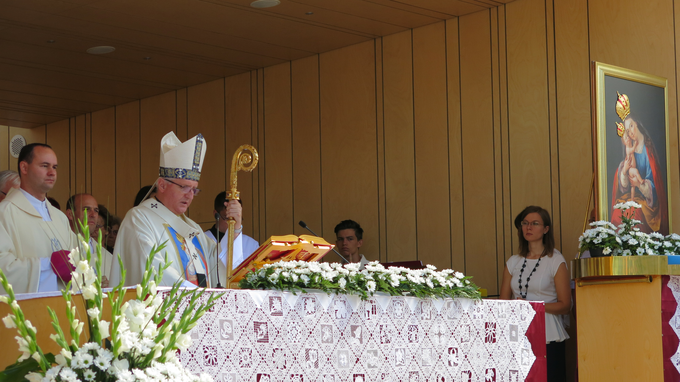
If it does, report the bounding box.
[382,30,418,261]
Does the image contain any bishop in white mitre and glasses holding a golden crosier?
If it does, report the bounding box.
[109,132,241,287]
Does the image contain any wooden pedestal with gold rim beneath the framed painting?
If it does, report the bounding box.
[571,256,680,382]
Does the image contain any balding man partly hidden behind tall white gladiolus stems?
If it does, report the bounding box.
[66,194,113,288]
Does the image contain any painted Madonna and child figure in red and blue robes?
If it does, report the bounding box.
[612,115,669,235]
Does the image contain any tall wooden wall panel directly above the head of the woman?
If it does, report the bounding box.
[506,0,552,242]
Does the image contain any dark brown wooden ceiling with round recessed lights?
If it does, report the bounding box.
[0,0,512,127]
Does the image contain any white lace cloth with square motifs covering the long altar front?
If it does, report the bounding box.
[173,290,536,382]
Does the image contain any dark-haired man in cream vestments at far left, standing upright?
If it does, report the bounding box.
[0,143,77,294]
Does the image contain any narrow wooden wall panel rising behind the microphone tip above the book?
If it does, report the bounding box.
[291,56,322,239]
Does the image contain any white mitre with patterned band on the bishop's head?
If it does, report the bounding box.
[158,131,208,182]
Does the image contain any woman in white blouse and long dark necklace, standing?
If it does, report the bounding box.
[500,206,571,382]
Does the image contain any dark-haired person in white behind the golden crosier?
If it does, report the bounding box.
[205,191,260,269]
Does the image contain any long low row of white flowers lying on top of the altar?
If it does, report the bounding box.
[239,261,481,300]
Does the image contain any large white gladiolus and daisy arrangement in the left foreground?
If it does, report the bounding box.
[0,222,222,382]
